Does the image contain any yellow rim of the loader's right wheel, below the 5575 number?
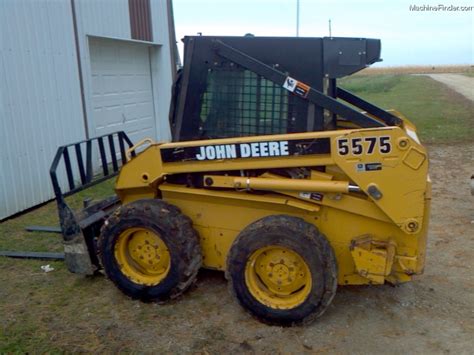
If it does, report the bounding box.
[245,246,312,309]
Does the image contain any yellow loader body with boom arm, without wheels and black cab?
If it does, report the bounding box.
[116,113,431,285]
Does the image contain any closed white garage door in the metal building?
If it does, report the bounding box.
[89,38,156,143]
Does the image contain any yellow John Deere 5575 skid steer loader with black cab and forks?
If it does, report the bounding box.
[51,36,431,325]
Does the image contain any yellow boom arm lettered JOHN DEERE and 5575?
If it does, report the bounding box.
[116,121,428,233]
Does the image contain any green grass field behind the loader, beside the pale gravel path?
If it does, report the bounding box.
[339,74,474,143]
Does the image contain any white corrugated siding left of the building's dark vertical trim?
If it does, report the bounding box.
[0,0,84,219]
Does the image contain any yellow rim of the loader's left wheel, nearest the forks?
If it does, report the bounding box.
[114,228,171,286]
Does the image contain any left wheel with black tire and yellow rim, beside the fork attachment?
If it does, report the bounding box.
[99,199,202,302]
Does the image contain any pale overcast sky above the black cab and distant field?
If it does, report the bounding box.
[173,0,474,67]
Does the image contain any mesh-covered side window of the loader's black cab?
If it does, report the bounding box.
[200,67,308,138]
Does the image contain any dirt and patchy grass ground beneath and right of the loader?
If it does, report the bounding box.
[0,144,474,353]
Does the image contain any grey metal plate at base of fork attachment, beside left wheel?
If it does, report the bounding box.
[63,233,96,275]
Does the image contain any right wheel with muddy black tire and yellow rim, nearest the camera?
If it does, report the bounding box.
[226,215,337,326]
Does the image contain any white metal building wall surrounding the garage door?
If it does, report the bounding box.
[0,0,173,220]
